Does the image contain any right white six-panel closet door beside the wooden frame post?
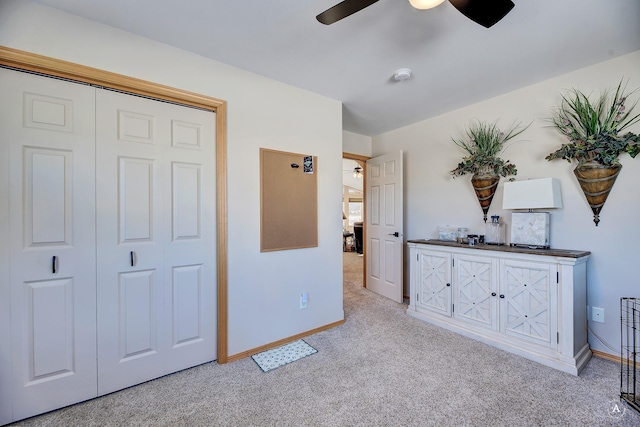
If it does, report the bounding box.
[96,90,216,394]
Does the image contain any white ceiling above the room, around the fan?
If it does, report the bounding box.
[32,0,640,136]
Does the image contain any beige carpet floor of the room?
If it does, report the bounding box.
[11,253,640,427]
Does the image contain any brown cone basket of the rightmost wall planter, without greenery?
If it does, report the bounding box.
[573,163,622,226]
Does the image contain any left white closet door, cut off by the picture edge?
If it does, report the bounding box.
[0,69,97,421]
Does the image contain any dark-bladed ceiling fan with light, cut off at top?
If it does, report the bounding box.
[316,0,514,28]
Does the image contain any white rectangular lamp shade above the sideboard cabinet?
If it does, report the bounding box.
[502,178,562,209]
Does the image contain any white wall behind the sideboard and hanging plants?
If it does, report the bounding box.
[373,51,640,354]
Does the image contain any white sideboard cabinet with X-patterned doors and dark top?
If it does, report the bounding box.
[407,240,591,375]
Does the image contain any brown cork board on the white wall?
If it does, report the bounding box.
[260,148,318,252]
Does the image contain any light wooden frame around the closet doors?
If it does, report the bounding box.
[0,46,229,363]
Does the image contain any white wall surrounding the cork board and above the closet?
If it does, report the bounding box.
[0,0,344,355]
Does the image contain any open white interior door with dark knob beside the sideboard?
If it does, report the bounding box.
[366,151,404,303]
